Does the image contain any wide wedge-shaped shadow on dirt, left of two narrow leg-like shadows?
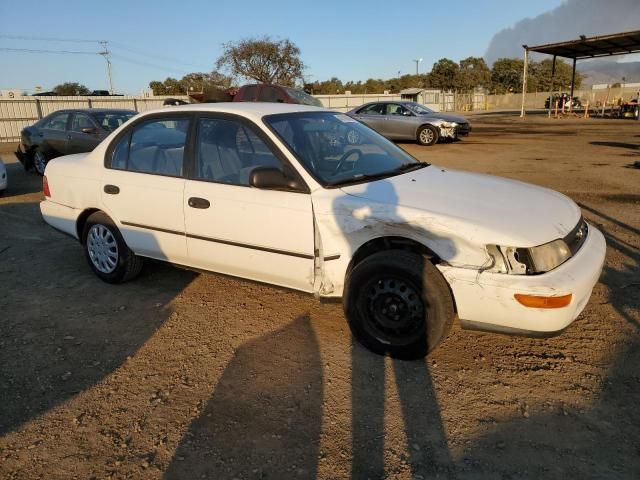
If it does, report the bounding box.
[165,316,324,479]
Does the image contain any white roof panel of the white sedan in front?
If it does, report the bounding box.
[138,102,331,119]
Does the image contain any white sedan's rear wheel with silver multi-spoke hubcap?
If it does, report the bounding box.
[82,212,143,283]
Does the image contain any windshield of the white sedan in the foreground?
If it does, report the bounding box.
[264,112,428,186]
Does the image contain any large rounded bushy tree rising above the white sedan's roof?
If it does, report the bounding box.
[216,36,305,86]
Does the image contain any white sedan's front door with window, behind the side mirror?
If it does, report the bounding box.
[184,116,314,292]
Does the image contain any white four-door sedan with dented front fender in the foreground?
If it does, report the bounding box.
[41,103,605,358]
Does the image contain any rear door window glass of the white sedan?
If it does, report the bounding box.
[110,118,190,177]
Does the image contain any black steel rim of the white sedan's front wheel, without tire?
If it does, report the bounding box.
[367,277,425,343]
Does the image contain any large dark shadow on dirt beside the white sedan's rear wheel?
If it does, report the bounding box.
[0,200,195,434]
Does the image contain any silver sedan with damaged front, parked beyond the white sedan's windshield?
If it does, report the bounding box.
[347,102,471,145]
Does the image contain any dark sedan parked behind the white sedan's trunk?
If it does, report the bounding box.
[16,108,136,175]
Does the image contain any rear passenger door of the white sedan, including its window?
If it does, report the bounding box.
[101,115,191,264]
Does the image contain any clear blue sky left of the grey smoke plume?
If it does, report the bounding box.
[0,0,563,94]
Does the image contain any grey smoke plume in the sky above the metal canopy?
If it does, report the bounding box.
[485,0,640,64]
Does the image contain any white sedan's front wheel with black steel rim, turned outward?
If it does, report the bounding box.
[343,250,455,360]
